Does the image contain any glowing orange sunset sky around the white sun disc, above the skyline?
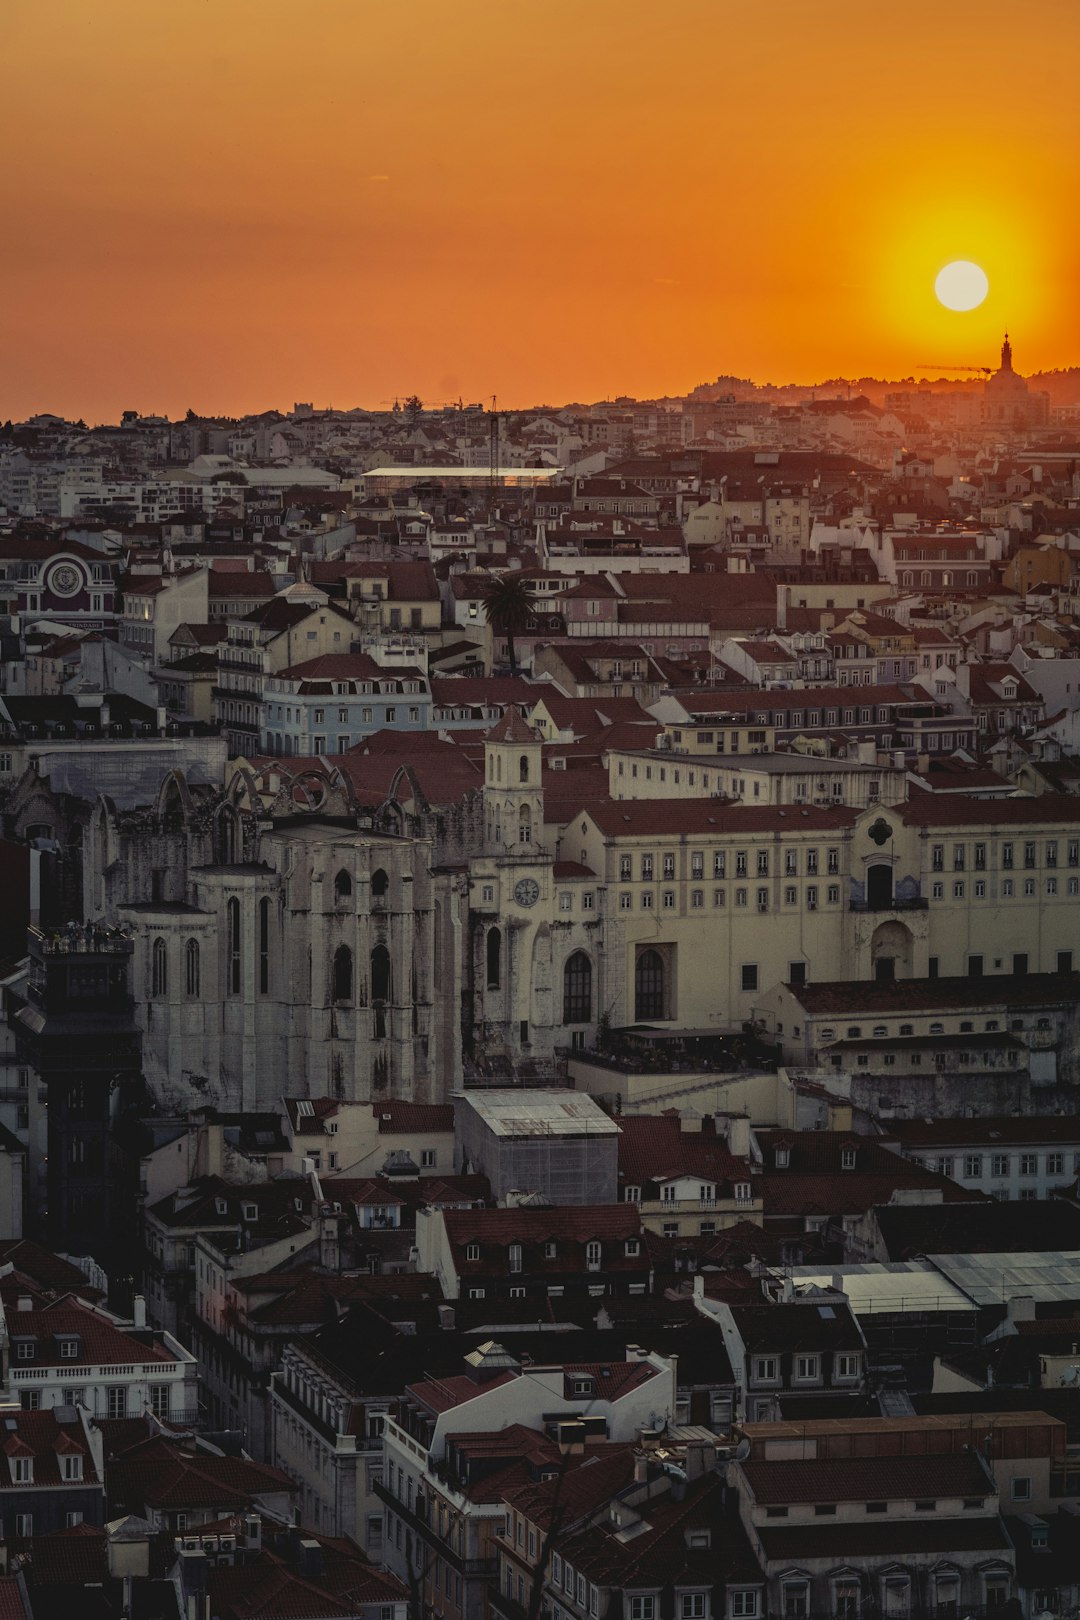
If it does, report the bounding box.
[0,0,1080,420]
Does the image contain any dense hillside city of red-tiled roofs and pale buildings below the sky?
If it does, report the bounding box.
[0,334,1080,1620]
